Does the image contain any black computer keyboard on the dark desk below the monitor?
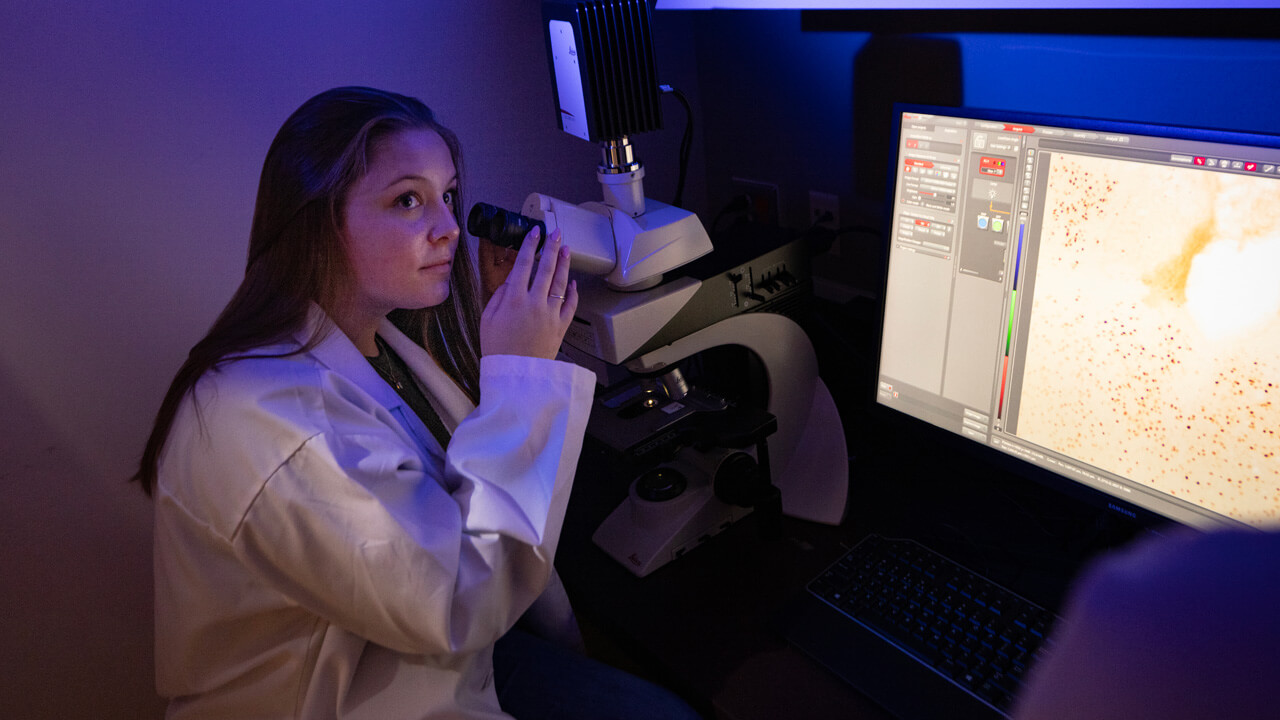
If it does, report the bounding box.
[808,536,1057,715]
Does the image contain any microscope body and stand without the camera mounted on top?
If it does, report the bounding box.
[524,193,849,575]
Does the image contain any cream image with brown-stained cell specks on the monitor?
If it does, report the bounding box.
[1014,154,1280,527]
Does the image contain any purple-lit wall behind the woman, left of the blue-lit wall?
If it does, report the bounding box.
[0,0,701,719]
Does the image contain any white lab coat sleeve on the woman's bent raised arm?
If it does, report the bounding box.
[225,356,594,655]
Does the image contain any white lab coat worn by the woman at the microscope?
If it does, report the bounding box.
[155,309,594,720]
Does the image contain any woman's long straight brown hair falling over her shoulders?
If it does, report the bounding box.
[132,87,480,495]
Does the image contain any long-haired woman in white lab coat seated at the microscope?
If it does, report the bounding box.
[137,87,701,719]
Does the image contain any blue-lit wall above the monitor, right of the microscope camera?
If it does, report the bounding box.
[691,10,1280,295]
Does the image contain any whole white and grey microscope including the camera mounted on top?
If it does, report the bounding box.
[483,0,849,577]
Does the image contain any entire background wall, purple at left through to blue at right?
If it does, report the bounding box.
[0,0,1280,719]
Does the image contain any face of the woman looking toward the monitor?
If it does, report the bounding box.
[343,129,460,316]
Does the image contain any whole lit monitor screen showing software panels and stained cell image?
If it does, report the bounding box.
[876,105,1280,528]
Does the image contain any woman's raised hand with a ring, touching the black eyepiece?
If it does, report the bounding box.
[480,228,577,359]
